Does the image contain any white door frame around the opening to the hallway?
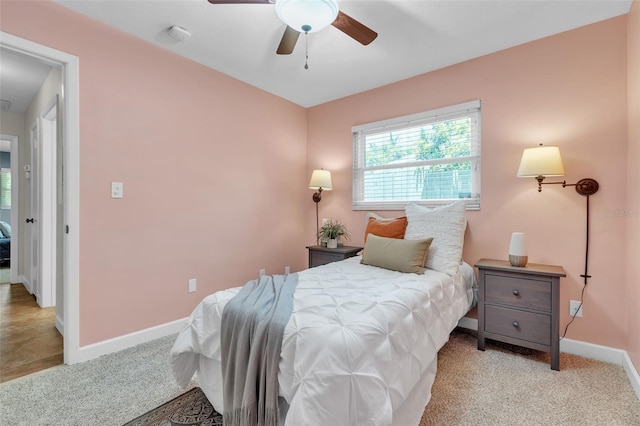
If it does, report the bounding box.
[0,32,83,364]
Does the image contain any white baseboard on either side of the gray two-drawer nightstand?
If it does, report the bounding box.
[458,317,640,400]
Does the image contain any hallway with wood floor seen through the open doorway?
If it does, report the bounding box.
[0,95,63,383]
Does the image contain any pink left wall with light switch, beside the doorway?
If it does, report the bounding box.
[1,2,309,346]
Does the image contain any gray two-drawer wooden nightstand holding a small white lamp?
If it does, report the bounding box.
[475,259,566,370]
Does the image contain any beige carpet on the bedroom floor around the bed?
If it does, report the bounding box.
[0,332,640,426]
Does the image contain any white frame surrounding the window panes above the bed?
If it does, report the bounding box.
[351,100,481,210]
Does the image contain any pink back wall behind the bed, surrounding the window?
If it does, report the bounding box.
[307,16,630,348]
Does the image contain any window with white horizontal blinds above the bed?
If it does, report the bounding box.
[352,100,480,210]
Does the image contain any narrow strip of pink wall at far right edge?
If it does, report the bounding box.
[626,0,640,371]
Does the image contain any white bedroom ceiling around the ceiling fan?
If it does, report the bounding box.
[1,0,632,111]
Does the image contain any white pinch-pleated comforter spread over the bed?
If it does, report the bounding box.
[171,256,474,426]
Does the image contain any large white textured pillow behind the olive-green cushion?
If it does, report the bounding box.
[404,201,467,276]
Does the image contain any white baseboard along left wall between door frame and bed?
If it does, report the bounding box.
[74,318,187,363]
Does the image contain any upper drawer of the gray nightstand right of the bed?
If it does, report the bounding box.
[484,273,551,312]
